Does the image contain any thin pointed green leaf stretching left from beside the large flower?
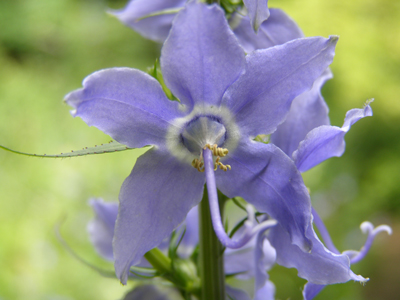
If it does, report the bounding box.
[0,141,139,158]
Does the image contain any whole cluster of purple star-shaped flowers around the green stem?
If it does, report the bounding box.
[61,0,390,300]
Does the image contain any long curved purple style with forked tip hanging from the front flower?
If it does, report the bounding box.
[203,147,277,249]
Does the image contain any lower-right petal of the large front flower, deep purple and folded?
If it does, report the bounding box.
[215,141,311,251]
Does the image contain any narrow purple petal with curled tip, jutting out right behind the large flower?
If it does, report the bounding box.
[293,103,372,172]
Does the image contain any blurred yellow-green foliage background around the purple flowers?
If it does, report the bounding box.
[0,0,400,300]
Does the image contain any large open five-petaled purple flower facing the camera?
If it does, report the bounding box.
[66,2,337,283]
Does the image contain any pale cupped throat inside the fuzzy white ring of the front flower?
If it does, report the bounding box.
[181,116,226,155]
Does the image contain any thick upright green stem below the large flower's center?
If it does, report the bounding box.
[199,188,225,300]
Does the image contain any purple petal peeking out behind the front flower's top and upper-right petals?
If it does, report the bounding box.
[233,8,304,53]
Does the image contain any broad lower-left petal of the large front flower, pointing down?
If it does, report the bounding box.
[113,149,205,284]
